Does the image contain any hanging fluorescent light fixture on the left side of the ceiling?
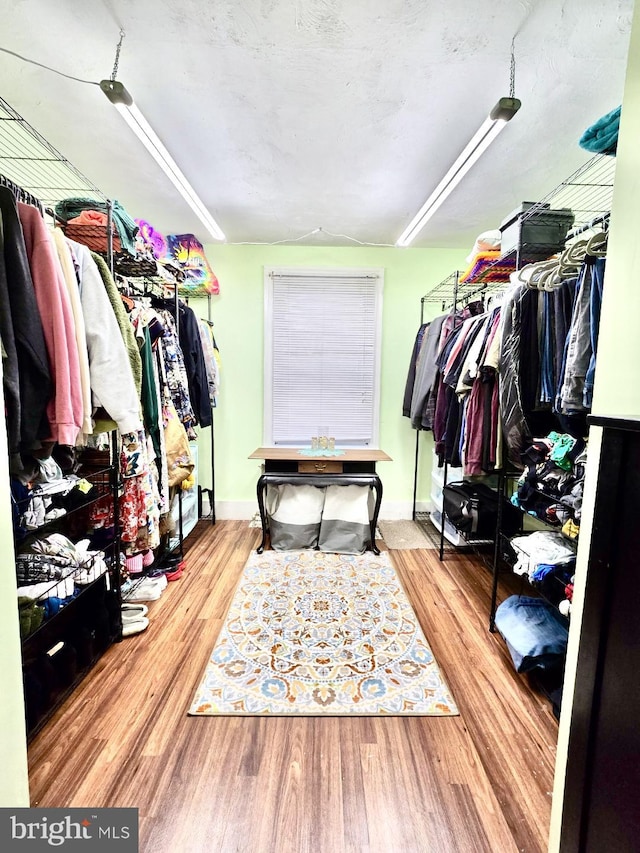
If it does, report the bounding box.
[100,80,225,240]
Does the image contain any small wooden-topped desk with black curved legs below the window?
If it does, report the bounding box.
[249,447,391,554]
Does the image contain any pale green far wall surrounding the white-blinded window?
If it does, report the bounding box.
[190,245,466,507]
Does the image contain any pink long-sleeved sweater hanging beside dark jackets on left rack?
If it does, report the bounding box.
[18,203,83,445]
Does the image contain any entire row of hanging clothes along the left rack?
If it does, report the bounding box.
[0,181,218,564]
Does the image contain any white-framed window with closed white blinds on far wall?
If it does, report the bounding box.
[264,267,383,447]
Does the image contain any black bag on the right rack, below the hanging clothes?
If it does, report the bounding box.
[442,480,522,539]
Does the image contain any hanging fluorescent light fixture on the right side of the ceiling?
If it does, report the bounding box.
[396,98,520,246]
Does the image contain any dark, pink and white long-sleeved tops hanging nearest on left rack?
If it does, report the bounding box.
[0,183,140,470]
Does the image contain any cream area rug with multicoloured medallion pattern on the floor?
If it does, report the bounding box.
[189,550,458,716]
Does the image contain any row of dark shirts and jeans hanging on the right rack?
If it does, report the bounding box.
[403,243,605,476]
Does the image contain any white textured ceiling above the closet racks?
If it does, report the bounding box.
[0,0,633,248]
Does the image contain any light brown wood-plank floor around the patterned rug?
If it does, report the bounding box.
[29,521,557,853]
